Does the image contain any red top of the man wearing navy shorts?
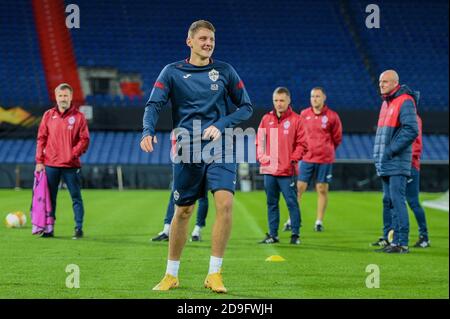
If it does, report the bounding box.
[300,105,342,164]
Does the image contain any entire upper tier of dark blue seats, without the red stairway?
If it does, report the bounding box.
[0,0,448,110]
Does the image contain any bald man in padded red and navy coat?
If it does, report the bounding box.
[373,70,419,253]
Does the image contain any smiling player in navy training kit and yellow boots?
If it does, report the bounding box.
[141,20,253,293]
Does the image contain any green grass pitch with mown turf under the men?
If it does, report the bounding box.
[0,190,449,298]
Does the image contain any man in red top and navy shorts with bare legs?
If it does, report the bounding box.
[284,87,342,232]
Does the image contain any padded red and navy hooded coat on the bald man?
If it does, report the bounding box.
[373,85,419,176]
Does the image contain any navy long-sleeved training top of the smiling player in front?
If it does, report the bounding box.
[143,60,253,137]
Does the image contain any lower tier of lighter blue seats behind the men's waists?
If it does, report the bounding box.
[0,132,448,164]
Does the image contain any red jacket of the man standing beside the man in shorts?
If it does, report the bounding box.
[256,107,306,176]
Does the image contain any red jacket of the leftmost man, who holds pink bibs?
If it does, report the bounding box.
[36,106,89,168]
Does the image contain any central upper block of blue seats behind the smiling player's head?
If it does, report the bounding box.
[67,0,378,108]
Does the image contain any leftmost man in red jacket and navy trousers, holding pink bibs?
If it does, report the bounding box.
[36,83,89,239]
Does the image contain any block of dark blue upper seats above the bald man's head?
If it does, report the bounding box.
[351,0,449,110]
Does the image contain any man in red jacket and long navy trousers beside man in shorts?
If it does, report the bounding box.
[256,87,306,245]
